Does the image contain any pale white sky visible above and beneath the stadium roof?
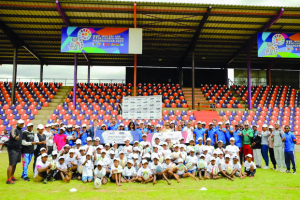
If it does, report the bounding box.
[0,0,300,85]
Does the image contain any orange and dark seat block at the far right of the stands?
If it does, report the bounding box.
[232,85,300,108]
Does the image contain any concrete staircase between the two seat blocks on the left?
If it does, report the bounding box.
[31,86,73,127]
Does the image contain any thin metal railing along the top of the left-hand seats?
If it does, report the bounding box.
[0,78,126,86]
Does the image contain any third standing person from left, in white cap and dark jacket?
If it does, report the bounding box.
[33,124,48,172]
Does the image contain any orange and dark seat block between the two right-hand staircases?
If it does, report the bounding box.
[201,84,243,108]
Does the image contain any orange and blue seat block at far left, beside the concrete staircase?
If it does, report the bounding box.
[0,82,62,131]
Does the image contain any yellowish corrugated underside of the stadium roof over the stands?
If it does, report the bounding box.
[0,0,300,69]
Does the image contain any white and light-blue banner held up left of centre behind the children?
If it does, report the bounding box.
[95,130,139,144]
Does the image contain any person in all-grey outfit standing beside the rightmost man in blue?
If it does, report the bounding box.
[271,122,286,172]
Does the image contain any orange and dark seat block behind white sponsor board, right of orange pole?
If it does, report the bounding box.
[138,83,187,108]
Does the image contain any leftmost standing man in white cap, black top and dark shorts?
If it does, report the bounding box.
[6,119,24,184]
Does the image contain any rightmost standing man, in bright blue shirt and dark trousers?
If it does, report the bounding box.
[282,125,296,175]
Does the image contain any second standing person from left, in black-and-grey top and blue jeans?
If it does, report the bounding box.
[21,123,35,181]
